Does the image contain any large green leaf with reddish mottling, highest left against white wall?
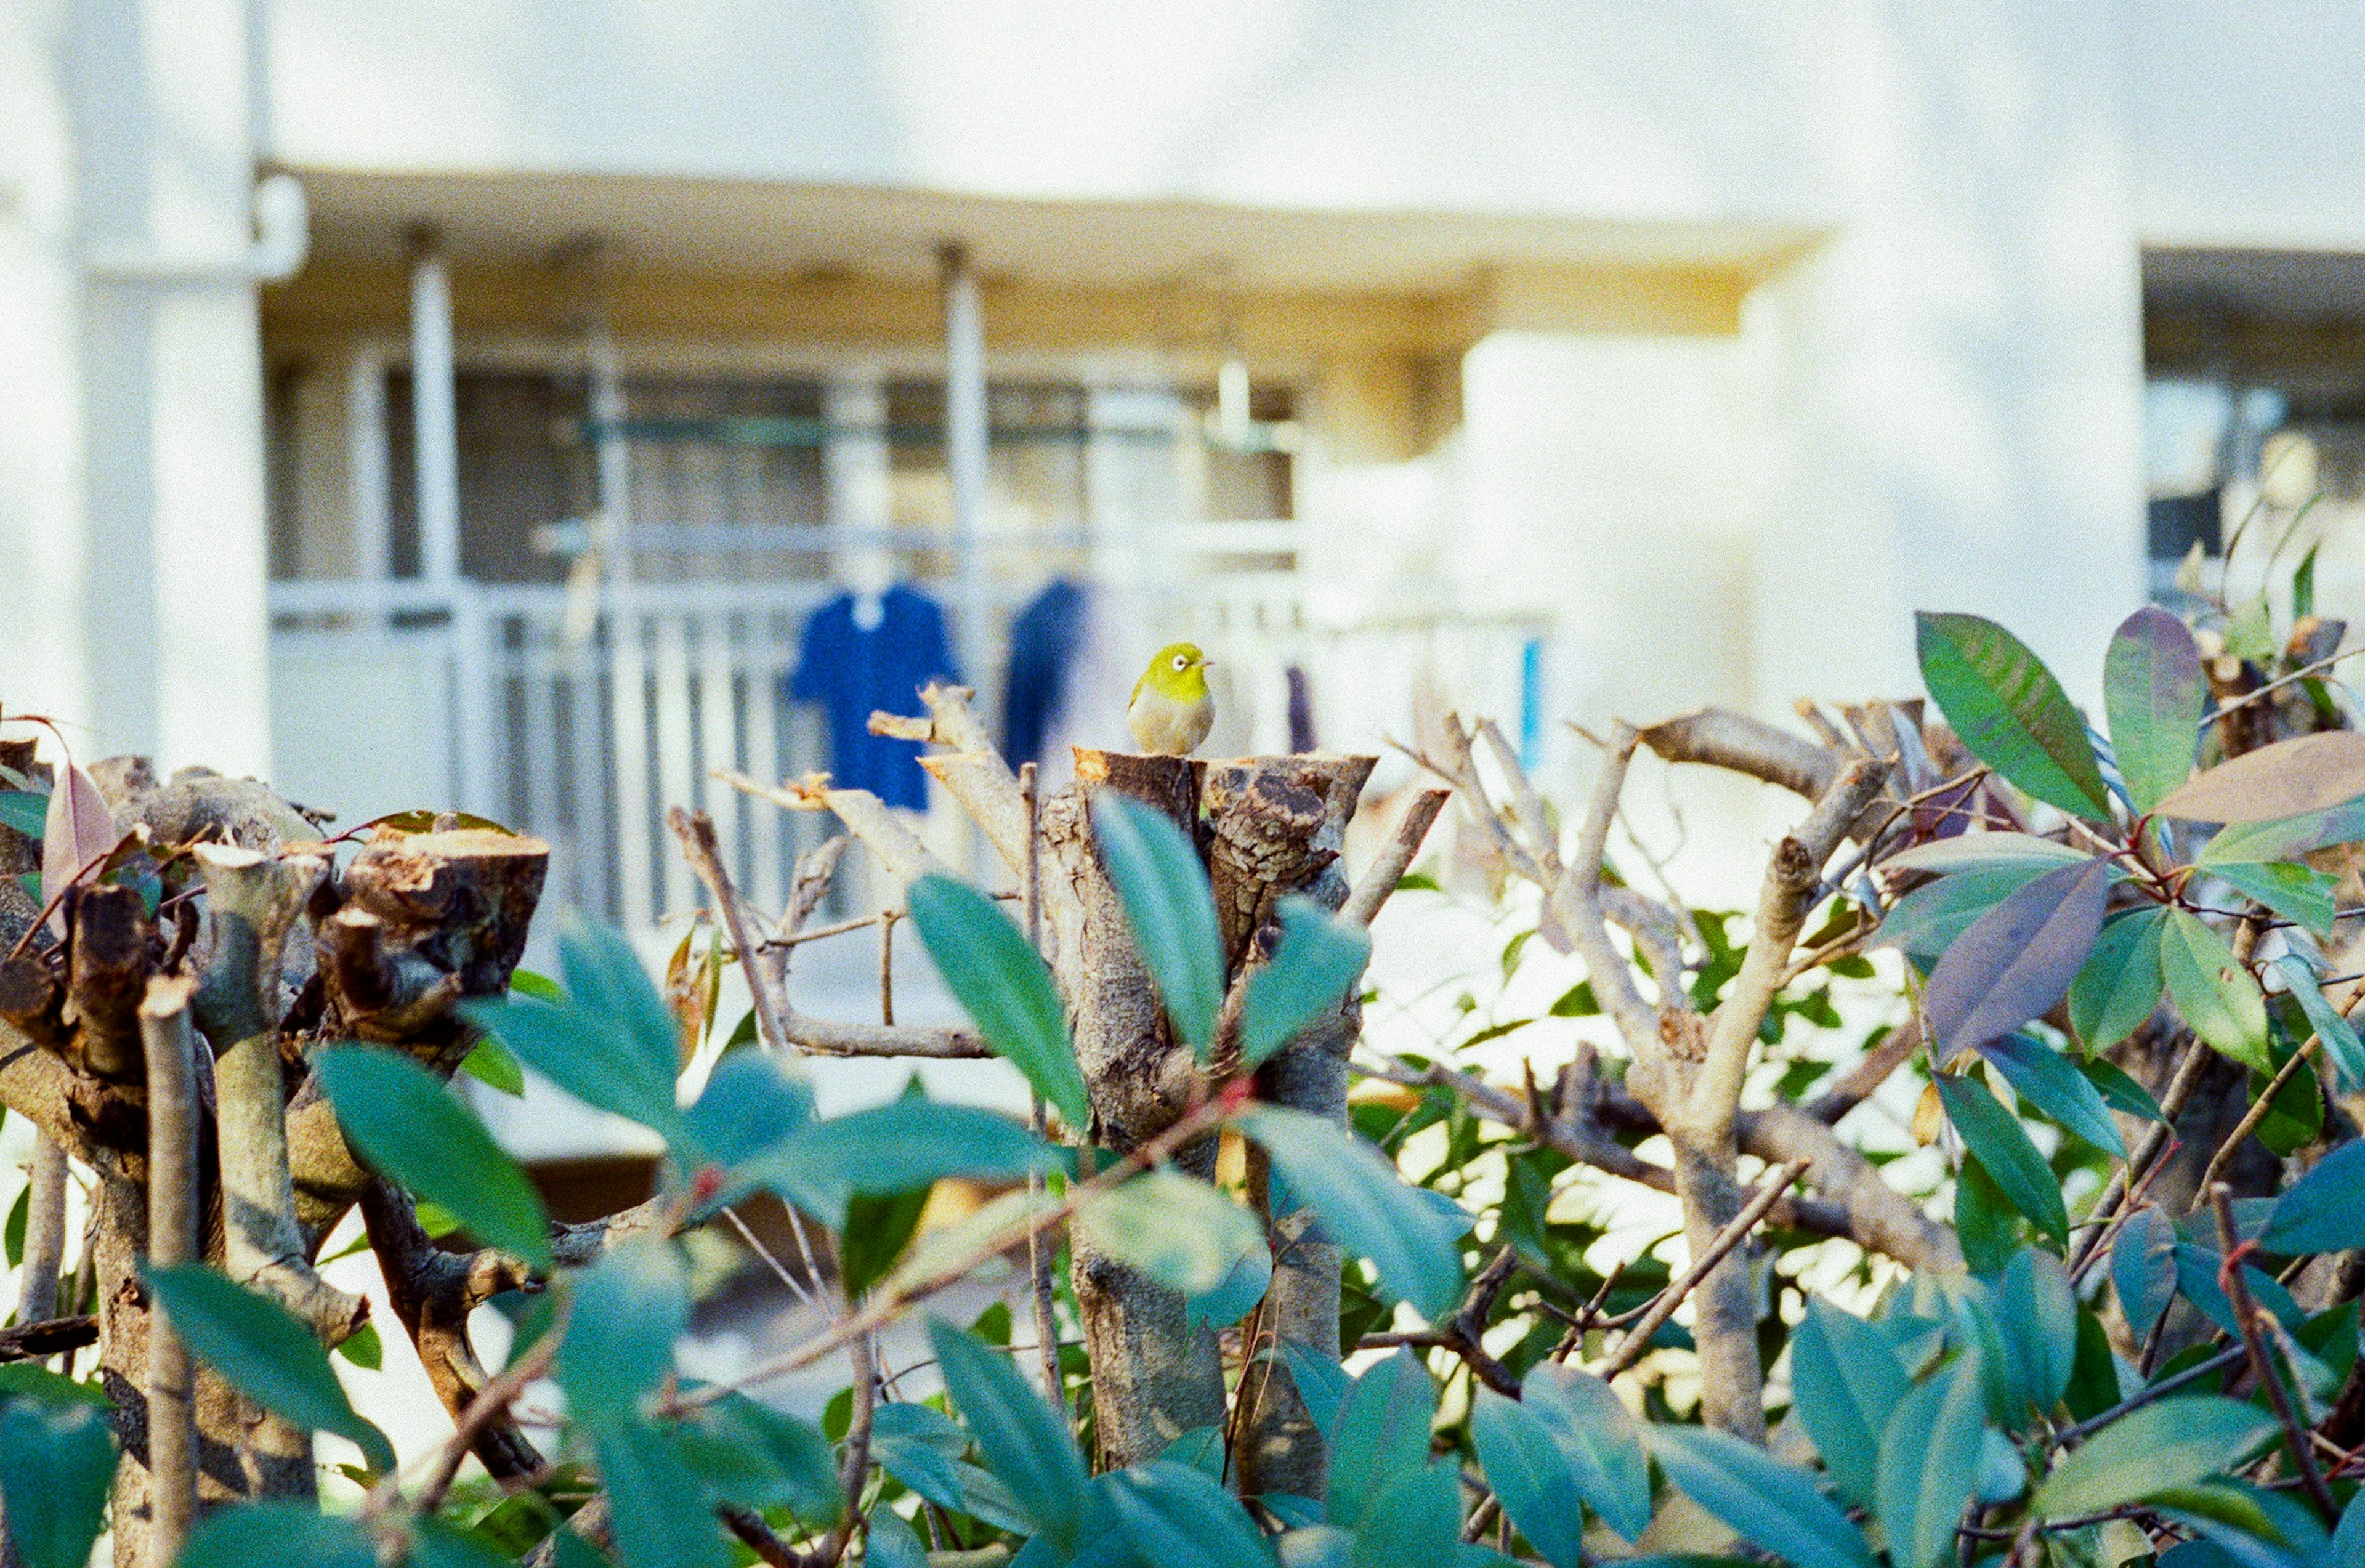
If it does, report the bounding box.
[1914,613,2109,823]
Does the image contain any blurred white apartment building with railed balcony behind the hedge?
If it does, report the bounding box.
[0,0,2365,903]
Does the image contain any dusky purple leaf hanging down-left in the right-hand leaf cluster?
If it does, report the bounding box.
[1923,861,2109,1062]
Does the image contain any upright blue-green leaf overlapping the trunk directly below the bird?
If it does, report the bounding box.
[1093,790,1223,1062]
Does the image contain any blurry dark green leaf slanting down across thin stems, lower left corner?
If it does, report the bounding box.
[140,1263,395,1476]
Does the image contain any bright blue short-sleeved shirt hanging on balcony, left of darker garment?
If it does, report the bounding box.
[783,584,960,811]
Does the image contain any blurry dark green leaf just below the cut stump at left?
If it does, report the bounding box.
[312,1045,554,1272]
